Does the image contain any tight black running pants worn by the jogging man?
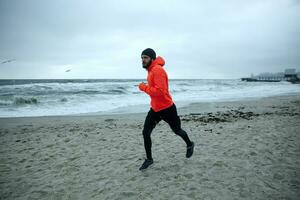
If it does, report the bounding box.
[143,104,192,159]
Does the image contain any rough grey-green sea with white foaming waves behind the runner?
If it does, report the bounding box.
[0,79,300,117]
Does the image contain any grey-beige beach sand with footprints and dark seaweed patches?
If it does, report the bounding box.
[0,95,300,200]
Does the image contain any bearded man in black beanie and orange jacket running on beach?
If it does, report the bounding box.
[139,48,194,170]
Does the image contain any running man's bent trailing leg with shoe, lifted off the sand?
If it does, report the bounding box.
[161,104,194,158]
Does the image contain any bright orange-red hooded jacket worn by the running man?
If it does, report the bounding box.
[139,56,174,112]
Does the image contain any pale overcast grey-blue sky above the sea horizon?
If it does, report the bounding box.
[0,0,300,78]
